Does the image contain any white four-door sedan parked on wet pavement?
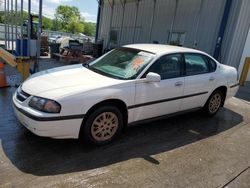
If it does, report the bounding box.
[13,44,239,145]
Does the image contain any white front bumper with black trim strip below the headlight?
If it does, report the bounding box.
[12,93,83,138]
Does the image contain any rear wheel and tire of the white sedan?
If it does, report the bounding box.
[203,90,224,116]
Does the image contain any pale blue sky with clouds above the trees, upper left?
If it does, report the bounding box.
[0,0,98,22]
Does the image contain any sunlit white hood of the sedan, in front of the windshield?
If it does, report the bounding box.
[22,64,123,96]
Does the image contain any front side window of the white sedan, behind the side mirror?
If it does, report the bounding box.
[144,54,181,80]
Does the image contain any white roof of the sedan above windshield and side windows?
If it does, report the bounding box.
[123,44,206,55]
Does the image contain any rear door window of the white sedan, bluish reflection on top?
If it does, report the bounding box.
[184,54,209,76]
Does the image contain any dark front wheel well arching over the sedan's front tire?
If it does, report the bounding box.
[80,99,128,137]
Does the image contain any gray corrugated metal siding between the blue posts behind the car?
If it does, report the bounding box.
[100,0,225,54]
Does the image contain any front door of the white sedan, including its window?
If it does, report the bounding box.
[131,54,184,121]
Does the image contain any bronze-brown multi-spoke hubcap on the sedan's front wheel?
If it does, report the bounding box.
[91,112,118,141]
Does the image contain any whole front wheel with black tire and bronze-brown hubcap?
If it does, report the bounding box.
[80,106,123,145]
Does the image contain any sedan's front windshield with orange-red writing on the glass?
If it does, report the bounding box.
[89,48,154,80]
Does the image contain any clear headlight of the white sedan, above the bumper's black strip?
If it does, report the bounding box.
[29,97,61,113]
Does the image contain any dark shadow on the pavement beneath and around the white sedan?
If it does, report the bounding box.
[0,89,243,176]
